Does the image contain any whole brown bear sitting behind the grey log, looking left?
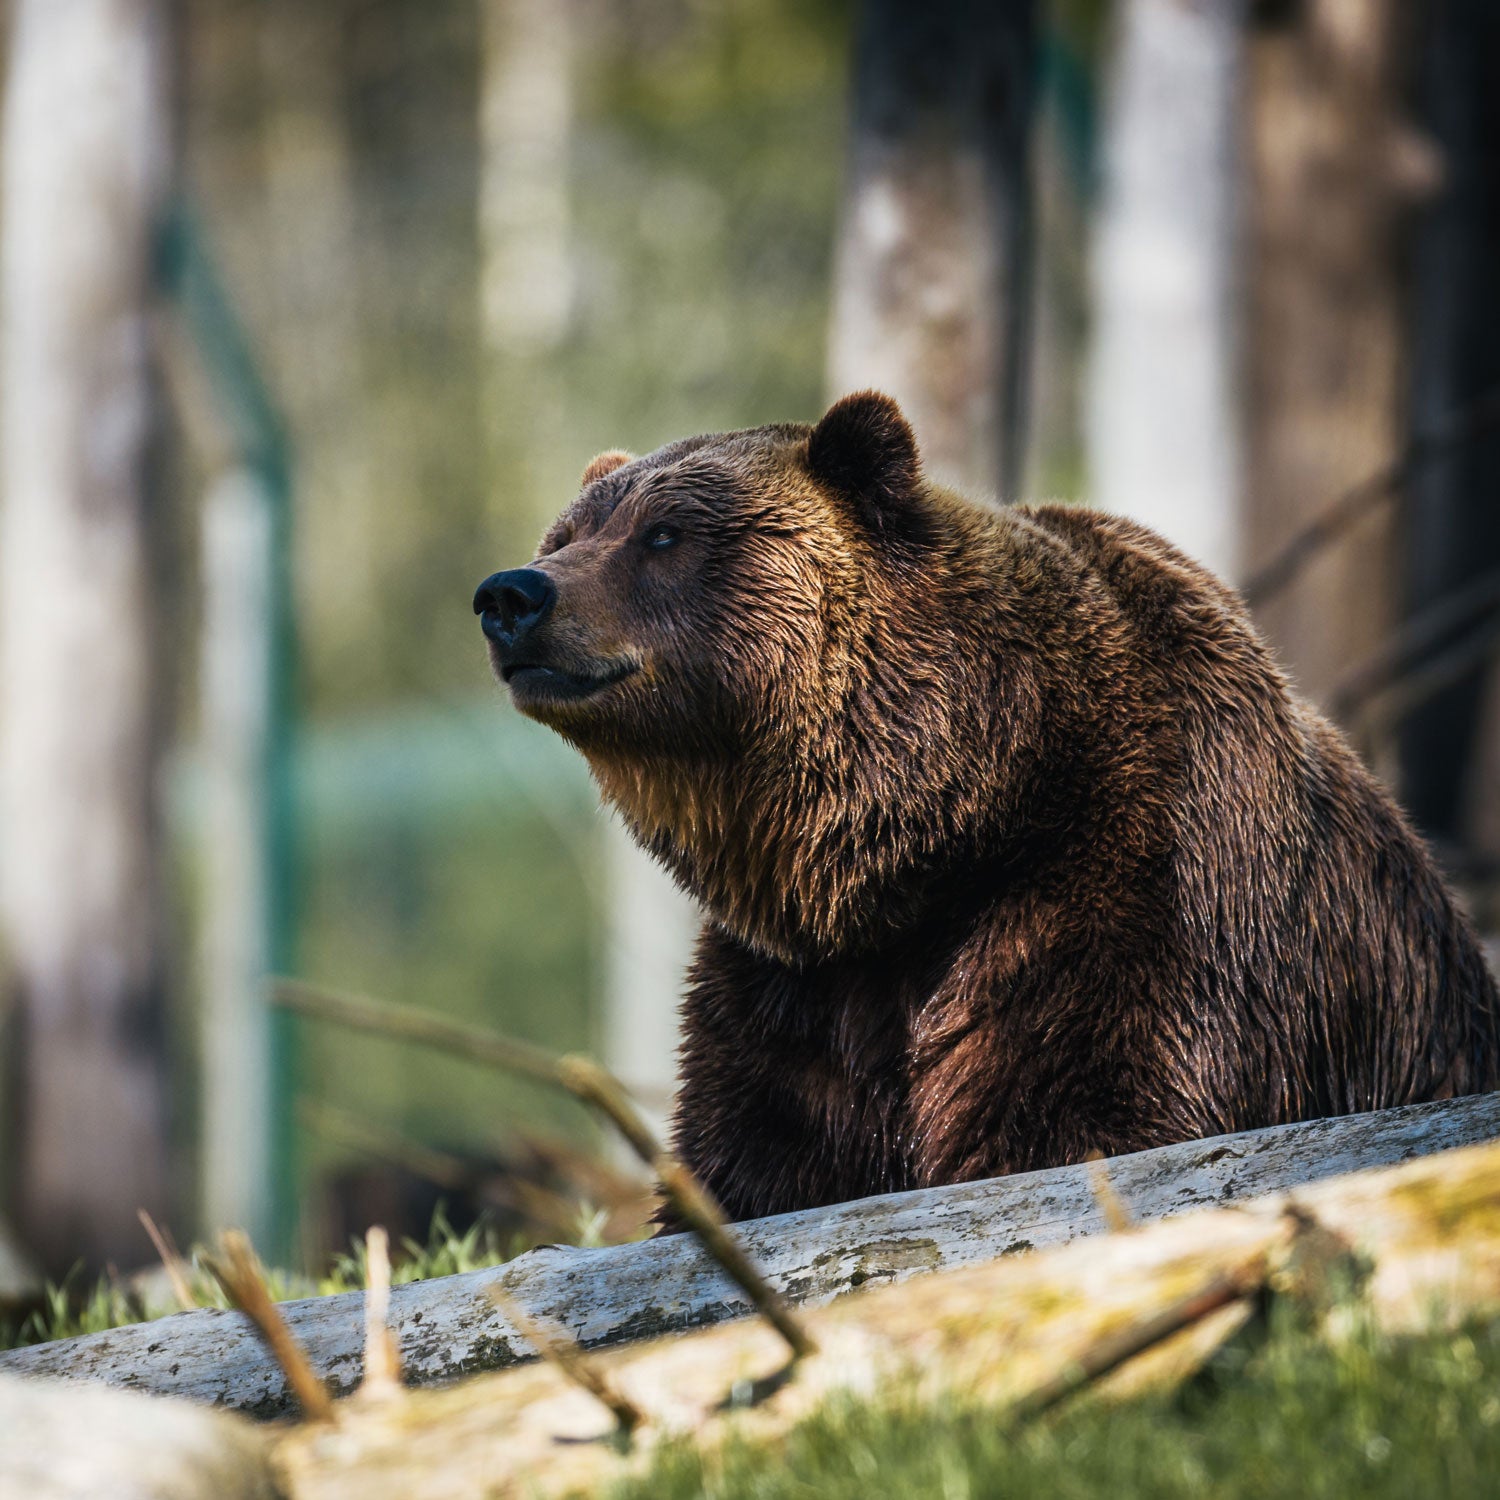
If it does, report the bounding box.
[474,393,1500,1218]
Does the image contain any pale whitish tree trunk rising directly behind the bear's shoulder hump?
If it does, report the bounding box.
[1089,0,1244,578]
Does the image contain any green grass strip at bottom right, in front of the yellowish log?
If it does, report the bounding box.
[612,1319,1500,1500]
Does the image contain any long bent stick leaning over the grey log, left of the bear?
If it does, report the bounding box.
[273,980,818,1359]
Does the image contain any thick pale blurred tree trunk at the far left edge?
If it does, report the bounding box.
[0,0,168,1274]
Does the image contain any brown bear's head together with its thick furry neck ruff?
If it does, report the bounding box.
[474,392,1038,962]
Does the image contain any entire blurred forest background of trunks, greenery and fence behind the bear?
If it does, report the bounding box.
[0,0,1500,1274]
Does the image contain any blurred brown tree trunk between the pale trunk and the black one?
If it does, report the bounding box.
[1245,0,1424,720]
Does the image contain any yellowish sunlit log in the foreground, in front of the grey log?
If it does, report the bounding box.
[273,1145,1500,1500]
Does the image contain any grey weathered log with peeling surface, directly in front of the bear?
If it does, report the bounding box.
[0,1095,1500,1416]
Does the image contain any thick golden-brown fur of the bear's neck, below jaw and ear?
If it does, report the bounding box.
[593,503,1037,966]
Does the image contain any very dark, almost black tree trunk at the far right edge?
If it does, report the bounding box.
[1401,0,1500,888]
